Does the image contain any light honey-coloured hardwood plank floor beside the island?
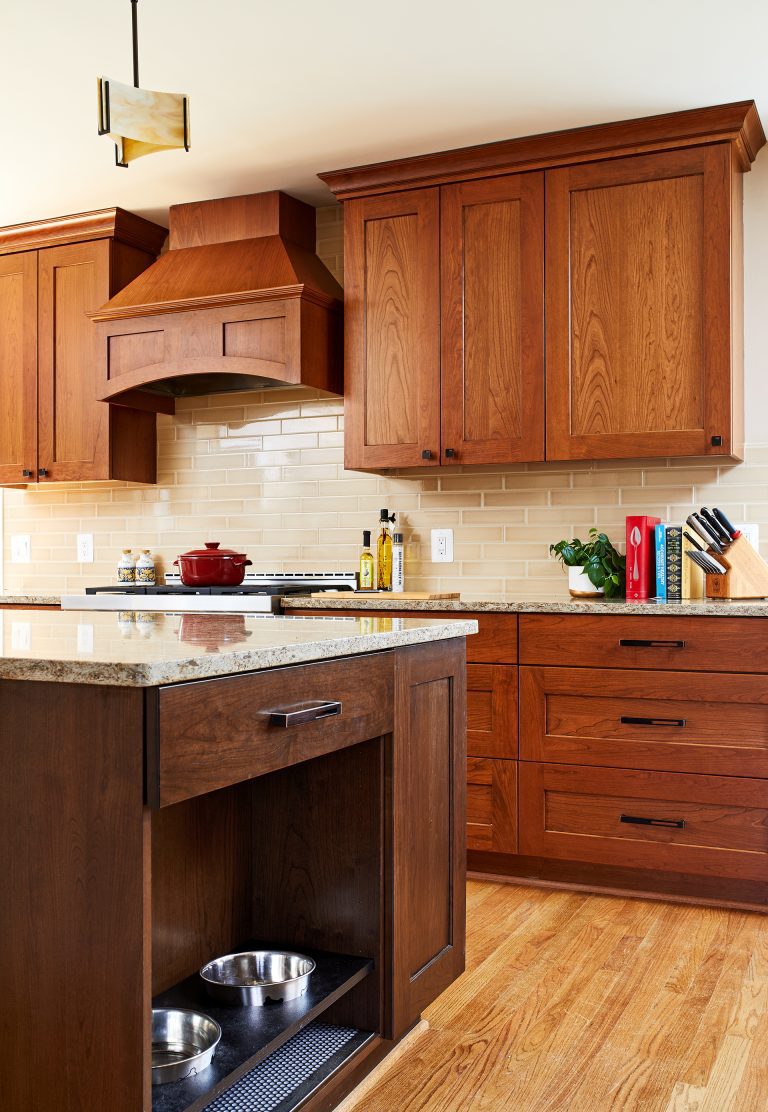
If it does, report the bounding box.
[345,882,768,1112]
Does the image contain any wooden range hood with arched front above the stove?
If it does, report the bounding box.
[92,191,343,413]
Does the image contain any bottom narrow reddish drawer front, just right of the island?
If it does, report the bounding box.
[467,757,518,853]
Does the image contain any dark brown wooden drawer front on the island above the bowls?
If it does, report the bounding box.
[156,653,393,807]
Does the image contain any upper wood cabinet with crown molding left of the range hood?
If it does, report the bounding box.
[0,209,166,486]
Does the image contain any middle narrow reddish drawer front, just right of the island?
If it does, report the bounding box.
[467,664,517,757]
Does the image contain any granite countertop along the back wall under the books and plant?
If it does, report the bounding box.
[282,590,768,618]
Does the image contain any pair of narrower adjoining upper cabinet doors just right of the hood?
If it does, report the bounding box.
[345,173,543,469]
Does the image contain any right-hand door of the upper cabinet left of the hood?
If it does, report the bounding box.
[39,239,110,481]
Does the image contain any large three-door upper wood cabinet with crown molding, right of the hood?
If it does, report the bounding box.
[321,101,765,469]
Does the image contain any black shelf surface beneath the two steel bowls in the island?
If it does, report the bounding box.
[152,942,373,1112]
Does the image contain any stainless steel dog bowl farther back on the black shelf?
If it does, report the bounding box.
[200,950,315,1006]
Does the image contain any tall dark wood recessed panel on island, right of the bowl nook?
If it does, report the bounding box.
[388,638,467,1037]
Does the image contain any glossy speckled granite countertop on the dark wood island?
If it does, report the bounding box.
[0,609,477,687]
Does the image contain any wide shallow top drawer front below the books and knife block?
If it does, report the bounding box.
[520,614,768,672]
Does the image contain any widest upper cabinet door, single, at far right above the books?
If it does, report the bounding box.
[547,145,738,459]
